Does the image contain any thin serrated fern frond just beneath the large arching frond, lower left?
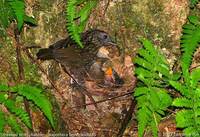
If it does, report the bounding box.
[4,99,32,129]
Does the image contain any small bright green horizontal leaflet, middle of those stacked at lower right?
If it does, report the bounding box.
[172,97,193,108]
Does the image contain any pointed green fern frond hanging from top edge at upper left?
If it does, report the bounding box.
[8,0,25,30]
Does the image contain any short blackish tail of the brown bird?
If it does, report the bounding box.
[36,48,54,60]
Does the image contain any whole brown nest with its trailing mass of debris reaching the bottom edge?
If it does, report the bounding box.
[50,45,136,136]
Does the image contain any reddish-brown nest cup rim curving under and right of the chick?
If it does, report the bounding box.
[85,56,136,97]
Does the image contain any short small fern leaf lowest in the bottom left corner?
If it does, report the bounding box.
[7,115,23,134]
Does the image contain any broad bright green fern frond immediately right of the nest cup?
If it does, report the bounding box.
[134,39,175,87]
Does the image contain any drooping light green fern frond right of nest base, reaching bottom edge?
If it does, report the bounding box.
[134,87,172,137]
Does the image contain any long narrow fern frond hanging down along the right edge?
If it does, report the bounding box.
[181,16,200,85]
